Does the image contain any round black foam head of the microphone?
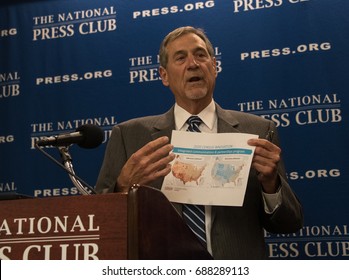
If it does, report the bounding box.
[76,124,103,149]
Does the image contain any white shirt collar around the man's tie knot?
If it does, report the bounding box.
[174,100,217,130]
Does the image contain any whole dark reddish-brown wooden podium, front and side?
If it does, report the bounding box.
[0,186,212,260]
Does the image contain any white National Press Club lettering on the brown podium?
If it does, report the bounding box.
[0,214,100,260]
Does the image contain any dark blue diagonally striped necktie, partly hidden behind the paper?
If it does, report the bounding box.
[183,116,206,247]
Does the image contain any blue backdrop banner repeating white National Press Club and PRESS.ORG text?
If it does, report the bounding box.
[0,0,349,259]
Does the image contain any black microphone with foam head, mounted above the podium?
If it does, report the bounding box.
[36,124,103,149]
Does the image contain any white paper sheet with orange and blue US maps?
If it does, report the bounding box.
[162,131,258,206]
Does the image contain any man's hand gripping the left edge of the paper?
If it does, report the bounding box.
[117,136,175,190]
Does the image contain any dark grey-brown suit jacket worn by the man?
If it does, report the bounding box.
[96,104,303,259]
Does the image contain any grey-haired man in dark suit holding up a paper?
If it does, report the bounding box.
[96,27,303,259]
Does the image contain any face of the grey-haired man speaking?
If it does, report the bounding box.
[160,33,217,109]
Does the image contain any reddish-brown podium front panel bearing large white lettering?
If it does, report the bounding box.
[0,194,127,260]
